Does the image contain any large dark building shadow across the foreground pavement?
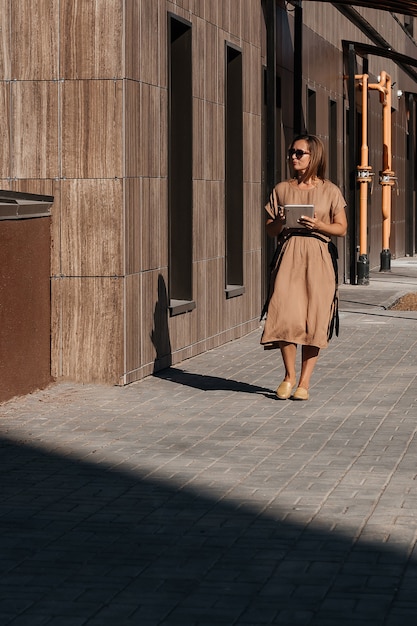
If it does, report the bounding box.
[0,439,417,626]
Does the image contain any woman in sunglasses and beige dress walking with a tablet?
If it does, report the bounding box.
[261,135,347,400]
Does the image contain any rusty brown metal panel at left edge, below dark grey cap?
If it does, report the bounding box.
[0,216,52,402]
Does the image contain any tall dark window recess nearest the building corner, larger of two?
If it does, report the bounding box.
[168,15,195,315]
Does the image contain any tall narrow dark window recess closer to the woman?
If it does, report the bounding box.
[225,45,245,298]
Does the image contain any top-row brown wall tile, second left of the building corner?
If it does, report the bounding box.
[10,0,59,80]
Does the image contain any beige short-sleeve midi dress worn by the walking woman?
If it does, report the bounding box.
[261,180,346,348]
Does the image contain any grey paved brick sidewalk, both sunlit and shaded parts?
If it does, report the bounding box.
[0,259,417,626]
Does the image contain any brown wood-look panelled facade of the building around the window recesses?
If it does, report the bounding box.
[0,0,417,392]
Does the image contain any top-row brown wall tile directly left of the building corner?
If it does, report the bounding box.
[60,0,124,79]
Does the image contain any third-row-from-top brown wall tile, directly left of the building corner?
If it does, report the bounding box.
[61,179,124,276]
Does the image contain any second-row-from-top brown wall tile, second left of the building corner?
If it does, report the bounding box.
[11,81,59,178]
